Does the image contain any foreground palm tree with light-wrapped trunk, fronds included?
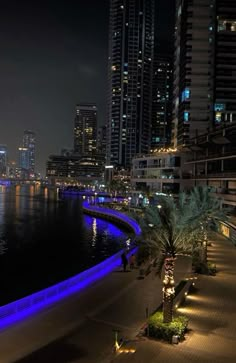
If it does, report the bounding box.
[140,193,200,323]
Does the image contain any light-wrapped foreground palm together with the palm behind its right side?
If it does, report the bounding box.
[135,187,226,323]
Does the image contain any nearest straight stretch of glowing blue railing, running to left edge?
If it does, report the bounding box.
[0,247,137,328]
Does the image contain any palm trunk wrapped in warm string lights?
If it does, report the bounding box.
[163,256,175,323]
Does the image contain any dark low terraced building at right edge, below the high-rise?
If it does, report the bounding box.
[185,122,236,206]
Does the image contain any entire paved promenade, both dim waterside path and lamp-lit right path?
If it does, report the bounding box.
[0,234,236,363]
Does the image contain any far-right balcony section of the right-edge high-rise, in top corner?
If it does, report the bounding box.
[213,0,236,126]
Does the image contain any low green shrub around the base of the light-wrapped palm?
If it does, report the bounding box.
[148,311,188,343]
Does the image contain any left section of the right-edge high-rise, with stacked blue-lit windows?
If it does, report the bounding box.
[173,0,214,146]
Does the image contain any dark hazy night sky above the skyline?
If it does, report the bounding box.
[0,0,174,175]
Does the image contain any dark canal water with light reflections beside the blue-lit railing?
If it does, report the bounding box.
[0,185,127,305]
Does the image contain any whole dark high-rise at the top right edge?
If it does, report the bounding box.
[172,0,236,145]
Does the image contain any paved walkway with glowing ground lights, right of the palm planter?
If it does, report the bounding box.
[113,234,236,363]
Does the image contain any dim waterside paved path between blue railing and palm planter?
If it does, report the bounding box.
[0,253,191,363]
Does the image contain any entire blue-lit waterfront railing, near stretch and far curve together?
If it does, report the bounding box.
[0,200,141,328]
